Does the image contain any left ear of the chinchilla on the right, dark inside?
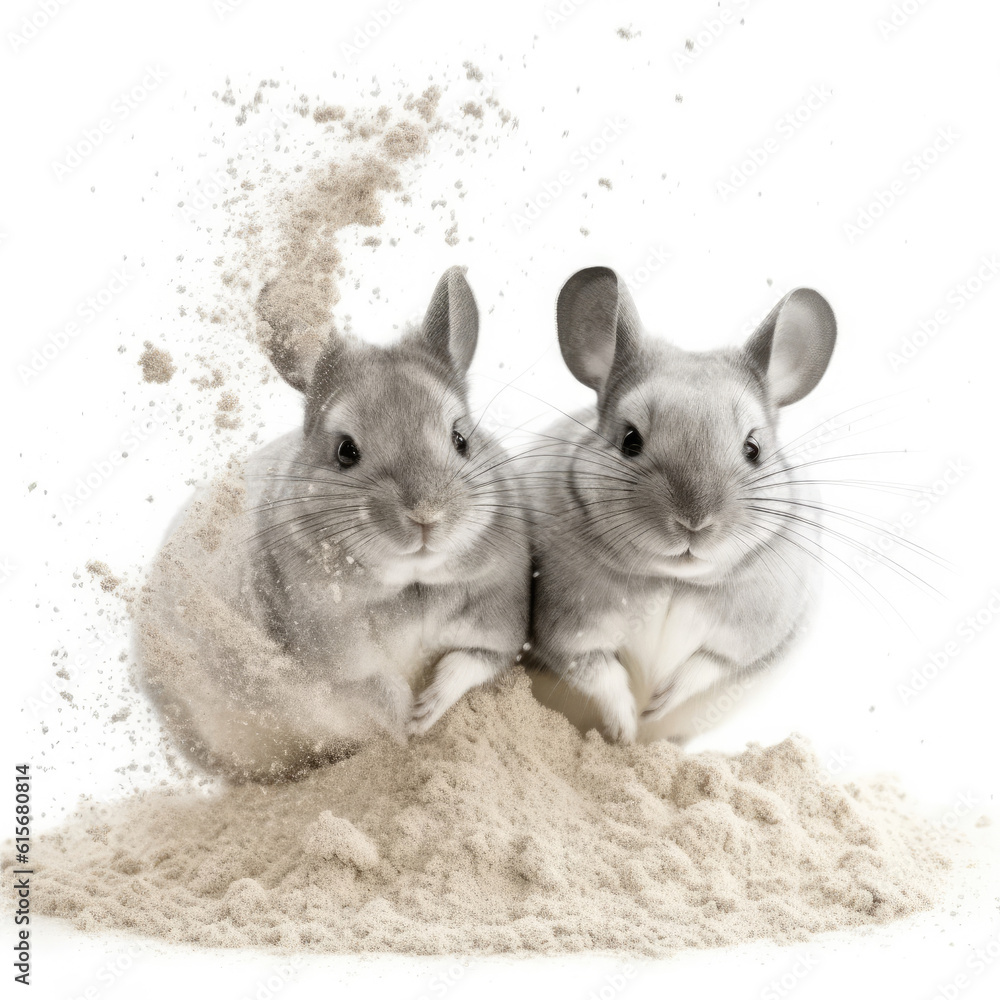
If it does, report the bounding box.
[556,267,642,399]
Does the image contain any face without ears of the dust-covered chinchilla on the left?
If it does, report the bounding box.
[290,348,490,565]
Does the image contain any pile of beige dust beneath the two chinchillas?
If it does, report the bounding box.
[34,675,948,956]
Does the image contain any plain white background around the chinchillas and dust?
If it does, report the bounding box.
[0,0,1000,998]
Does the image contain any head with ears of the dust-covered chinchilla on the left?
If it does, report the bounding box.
[258,267,500,582]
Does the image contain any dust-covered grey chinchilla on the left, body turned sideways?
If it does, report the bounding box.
[138,268,530,780]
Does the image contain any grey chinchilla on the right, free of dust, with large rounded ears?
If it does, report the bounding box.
[526,267,836,742]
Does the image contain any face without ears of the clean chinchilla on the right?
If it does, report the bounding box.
[588,344,777,578]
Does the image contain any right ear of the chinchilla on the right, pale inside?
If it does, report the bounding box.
[744,288,837,406]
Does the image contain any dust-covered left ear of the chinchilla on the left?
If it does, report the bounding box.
[256,278,337,393]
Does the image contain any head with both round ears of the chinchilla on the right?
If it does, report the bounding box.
[556,267,837,578]
